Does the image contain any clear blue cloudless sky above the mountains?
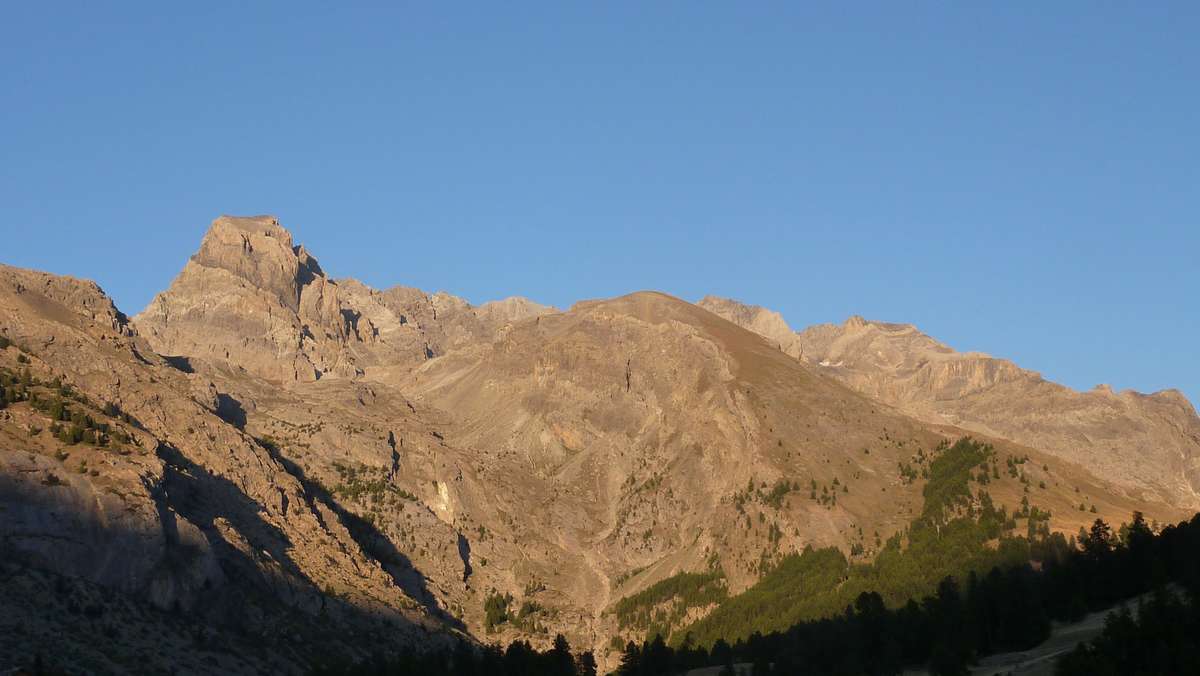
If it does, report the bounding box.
[0,2,1200,402]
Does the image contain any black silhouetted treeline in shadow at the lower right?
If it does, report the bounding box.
[617,513,1200,676]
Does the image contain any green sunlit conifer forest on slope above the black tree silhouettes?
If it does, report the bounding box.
[604,438,998,650]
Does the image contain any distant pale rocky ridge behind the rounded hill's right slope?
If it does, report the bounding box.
[701,298,1200,508]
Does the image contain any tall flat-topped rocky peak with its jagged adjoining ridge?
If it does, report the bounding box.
[136,216,553,383]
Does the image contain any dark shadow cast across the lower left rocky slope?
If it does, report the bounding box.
[0,443,462,670]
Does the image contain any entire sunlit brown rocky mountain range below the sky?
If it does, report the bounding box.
[0,216,1200,672]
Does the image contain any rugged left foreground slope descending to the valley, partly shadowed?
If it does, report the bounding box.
[0,261,445,671]
